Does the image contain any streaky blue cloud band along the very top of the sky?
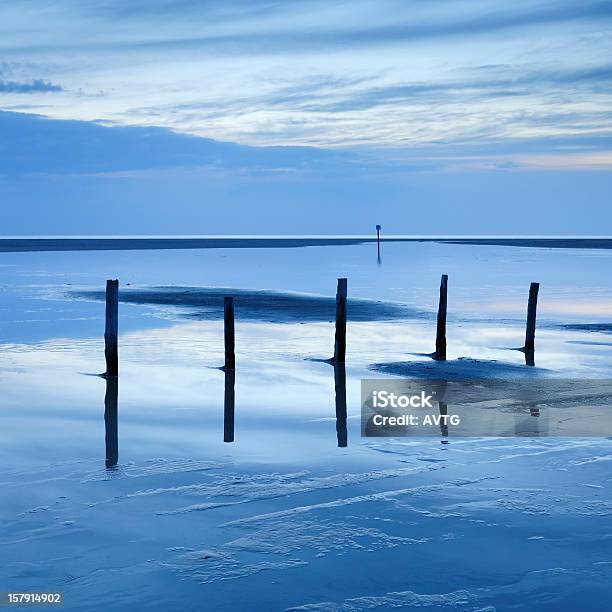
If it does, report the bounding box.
[2,0,612,55]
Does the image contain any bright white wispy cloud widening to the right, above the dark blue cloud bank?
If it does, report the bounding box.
[119,59,612,148]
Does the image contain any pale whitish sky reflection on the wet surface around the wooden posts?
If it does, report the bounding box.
[0,321,610,465]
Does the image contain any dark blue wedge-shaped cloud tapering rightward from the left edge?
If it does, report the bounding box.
[0,111,350,176]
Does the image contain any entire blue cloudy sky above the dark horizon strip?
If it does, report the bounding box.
[0,0,612,234]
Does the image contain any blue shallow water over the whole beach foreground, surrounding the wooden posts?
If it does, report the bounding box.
[0,243,612,610]
